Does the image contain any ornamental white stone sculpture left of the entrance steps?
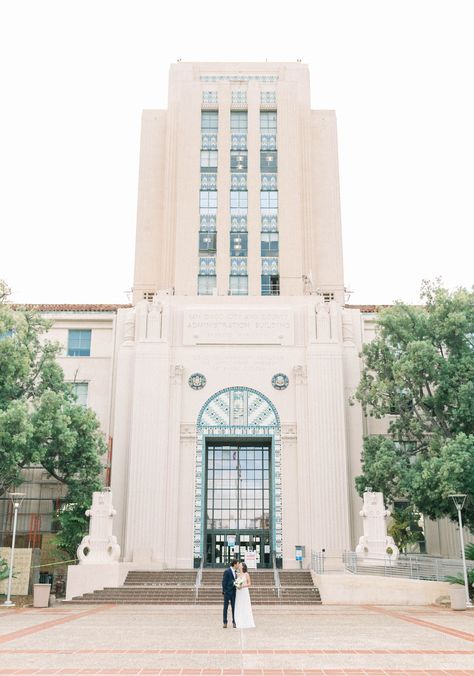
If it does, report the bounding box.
[77,491,120,564]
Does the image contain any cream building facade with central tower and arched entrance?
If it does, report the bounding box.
[1,63,466,568]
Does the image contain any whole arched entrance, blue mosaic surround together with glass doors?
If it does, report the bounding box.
[194,387,282,568]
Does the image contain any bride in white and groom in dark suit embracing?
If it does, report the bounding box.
[222,559,255,629]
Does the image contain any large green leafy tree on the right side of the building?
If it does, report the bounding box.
[355,282,474,530]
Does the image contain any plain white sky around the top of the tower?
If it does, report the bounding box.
[0,0,474,303]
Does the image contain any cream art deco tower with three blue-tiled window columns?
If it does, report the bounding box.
[134,63,344,302]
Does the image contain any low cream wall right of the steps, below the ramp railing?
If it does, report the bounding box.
[312,572,450,606]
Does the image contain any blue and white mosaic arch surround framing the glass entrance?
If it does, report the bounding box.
[194,387,282,559]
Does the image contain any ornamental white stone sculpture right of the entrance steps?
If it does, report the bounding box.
[356,491,399,564]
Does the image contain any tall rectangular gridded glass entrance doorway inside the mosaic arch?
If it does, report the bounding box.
[205,439,272,568]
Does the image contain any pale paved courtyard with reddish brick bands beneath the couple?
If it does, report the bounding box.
[0,605,474,675]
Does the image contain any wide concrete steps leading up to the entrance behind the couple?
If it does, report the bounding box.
[67,569,321,605]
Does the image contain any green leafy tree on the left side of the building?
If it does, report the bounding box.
[0,284,106,556]
